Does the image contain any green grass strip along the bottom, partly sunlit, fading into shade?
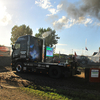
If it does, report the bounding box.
[21,85,100,100]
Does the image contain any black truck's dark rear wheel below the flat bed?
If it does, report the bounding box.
[49,66,61,78]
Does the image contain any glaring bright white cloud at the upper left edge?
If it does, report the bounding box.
[0,3,11,26]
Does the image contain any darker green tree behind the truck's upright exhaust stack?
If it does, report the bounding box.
[35,27,60,47]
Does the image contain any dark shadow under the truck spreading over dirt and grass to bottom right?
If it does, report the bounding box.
[15,72,100,100]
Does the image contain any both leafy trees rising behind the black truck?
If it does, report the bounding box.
[10,25,60,48]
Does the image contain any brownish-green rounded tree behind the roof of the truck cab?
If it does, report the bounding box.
[10,25,33,45]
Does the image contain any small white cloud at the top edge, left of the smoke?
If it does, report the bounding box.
[35,0,52,9]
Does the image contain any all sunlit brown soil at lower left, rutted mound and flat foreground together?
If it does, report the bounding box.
[0,66,41,100]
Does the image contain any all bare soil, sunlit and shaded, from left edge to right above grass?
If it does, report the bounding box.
[0,66,100,100]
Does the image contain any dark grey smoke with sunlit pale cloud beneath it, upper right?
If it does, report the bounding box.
[53,0,100,29]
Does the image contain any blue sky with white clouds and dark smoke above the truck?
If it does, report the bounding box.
[0,0,100,56]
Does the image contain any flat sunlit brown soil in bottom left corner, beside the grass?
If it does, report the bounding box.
[0,87,40,100]
